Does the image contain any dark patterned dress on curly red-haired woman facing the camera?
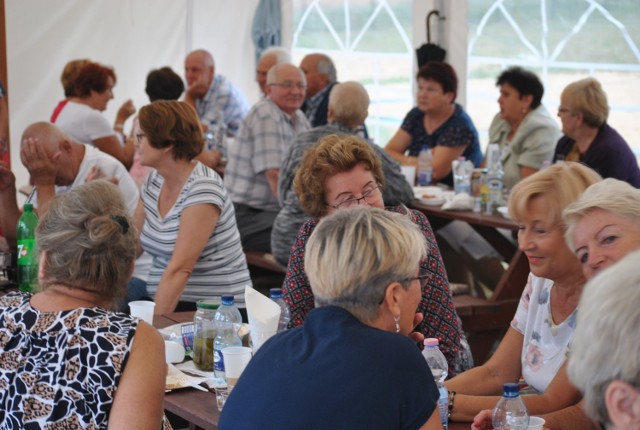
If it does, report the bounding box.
[282,206,473,377]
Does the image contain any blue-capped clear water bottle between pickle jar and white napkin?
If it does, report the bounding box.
[213,296,242,379]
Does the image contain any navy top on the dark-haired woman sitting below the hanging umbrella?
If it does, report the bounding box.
[400,103,482,186]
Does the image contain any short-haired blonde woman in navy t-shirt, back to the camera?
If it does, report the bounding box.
[220,207,441,429]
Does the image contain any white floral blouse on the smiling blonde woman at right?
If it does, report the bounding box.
[511,273,577,393]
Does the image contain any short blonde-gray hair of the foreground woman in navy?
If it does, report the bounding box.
[304,206,428,322]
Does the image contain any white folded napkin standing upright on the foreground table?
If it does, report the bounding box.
[244,287,280,352]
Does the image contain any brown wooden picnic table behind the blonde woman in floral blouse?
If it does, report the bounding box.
[410,200,529,364]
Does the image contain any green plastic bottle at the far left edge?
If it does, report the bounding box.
[16,203,38,292]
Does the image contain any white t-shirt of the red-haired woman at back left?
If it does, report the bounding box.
[55,101,117,145]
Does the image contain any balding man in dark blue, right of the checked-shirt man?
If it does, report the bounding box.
[300,53,338,127]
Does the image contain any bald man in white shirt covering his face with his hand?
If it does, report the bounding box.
[0,122,139,243]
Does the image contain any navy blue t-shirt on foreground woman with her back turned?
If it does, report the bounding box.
[219,306,438,430]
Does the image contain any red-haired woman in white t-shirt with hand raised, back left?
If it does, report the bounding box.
[55,63,136,168]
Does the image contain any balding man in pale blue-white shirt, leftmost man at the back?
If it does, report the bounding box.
[184,49,249,135]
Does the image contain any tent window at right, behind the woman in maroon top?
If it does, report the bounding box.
[467,0,640,155]
